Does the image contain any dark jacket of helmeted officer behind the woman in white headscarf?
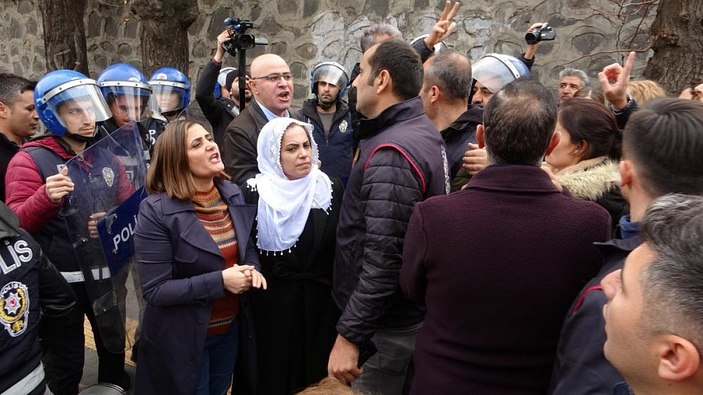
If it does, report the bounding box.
[300,99,354,184]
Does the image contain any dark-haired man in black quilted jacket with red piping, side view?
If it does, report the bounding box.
[328,39,449,394]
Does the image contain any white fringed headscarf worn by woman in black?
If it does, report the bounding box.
[247,117,332,251]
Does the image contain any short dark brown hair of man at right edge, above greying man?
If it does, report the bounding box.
[623,98,703,197]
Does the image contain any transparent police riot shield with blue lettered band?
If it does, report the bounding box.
[62,123,146,353]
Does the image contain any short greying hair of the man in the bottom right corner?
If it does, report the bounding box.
[640,194,703,353]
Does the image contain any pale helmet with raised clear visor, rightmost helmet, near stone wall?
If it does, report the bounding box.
[471,53,530,93]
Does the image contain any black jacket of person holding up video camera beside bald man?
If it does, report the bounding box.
[195,59,239,147]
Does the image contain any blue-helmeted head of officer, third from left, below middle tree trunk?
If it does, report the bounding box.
[149,67,190,114]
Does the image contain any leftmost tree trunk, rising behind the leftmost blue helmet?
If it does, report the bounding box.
[39,0,88,75]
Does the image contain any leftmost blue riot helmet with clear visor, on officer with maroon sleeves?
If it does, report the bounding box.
[34,70,112,138]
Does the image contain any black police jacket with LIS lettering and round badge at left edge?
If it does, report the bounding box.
[0,203,75,394]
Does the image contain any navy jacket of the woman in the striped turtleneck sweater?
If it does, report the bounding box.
[134,182,259,395]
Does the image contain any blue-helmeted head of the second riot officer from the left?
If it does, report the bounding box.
[98,63,151,126]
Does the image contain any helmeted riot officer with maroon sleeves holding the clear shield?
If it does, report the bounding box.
[6,70,131,395]
